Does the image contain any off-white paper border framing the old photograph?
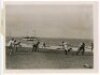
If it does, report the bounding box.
[0,0,99,75]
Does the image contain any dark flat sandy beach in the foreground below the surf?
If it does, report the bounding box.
[6,47,93,69]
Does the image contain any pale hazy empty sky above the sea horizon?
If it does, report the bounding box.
[6,4,93,39]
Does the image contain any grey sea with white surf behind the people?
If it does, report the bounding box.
[6,37,93,52]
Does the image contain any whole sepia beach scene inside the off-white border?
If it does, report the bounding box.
[5,2,94,70]
